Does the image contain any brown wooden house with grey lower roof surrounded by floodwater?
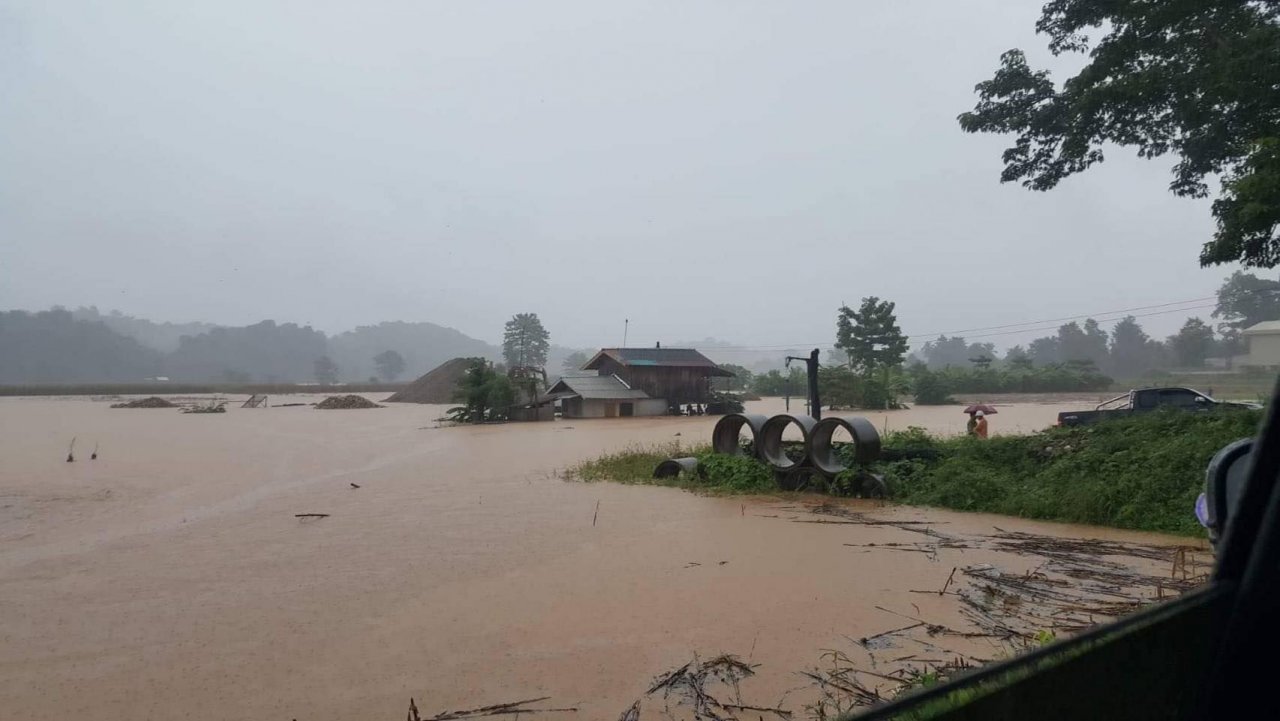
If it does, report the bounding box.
[547,347,733,417]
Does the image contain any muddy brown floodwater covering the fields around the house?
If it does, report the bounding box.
[0,397,1203,721]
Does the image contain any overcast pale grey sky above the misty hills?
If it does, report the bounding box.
[0,0,1233,346]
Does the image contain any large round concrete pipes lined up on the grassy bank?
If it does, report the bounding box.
[654,414,884,494]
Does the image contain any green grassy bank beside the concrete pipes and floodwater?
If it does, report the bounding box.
[568,410,1262,535]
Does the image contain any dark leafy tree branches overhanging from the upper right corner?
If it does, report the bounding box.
[960,0,1280,268]
